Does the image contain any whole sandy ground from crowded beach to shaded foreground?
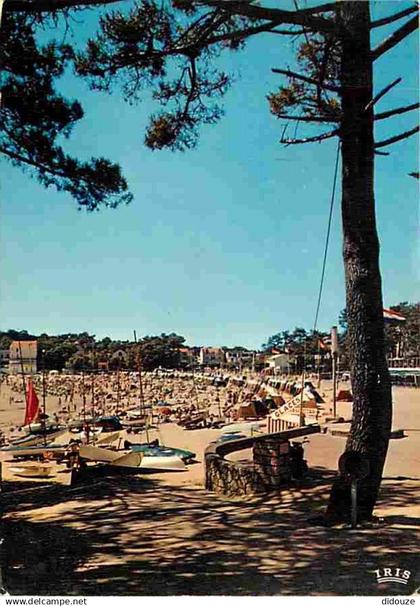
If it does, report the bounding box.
[0,371,420,596]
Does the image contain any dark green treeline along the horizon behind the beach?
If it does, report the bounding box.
[0,302,420,371]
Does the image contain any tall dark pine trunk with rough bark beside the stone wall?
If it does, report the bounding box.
[327,0,392,520]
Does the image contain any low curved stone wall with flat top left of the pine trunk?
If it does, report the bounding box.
[205,424,320,496]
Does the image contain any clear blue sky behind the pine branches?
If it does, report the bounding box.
[0,2,420,347]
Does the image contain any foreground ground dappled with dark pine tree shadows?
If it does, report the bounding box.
[3,468,420,595]
